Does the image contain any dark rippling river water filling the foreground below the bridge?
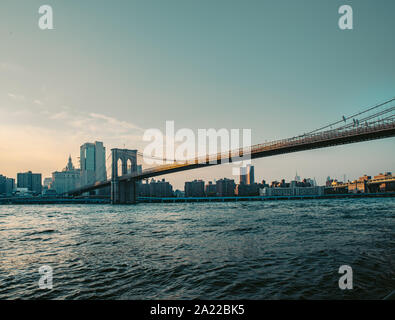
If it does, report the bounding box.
[0,198,395,299]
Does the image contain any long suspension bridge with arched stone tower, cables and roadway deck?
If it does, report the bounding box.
[66,98,395,204]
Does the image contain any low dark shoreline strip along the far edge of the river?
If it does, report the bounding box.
[0,192,395,205]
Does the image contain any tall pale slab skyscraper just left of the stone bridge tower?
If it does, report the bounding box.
[80,141,107,186]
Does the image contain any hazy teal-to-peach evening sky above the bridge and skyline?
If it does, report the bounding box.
[0,0,395,188]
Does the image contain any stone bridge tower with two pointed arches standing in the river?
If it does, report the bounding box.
[111,149,137,204]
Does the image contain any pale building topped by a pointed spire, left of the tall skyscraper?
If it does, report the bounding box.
[50,156,81,194]
